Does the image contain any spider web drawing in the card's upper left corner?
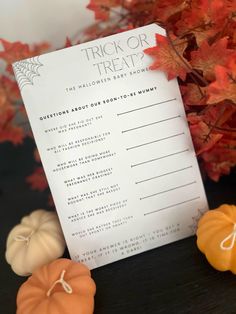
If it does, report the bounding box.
[13,56,43,90]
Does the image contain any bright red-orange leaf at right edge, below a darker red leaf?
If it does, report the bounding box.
[207,65,236,104]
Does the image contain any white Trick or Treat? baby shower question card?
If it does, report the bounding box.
[13,24,208,269]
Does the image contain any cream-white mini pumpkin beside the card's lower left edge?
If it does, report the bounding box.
[6,209,65,276]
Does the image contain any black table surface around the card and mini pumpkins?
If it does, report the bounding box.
[0,140,236,314]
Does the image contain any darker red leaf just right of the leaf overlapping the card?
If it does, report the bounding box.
[190,37,234,81]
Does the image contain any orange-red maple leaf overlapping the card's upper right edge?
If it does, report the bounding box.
[144,34,191,80]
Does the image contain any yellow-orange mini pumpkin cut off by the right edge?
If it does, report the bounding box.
[197,204,236,274]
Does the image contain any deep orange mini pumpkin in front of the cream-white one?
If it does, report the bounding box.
[17,258,96,314]
